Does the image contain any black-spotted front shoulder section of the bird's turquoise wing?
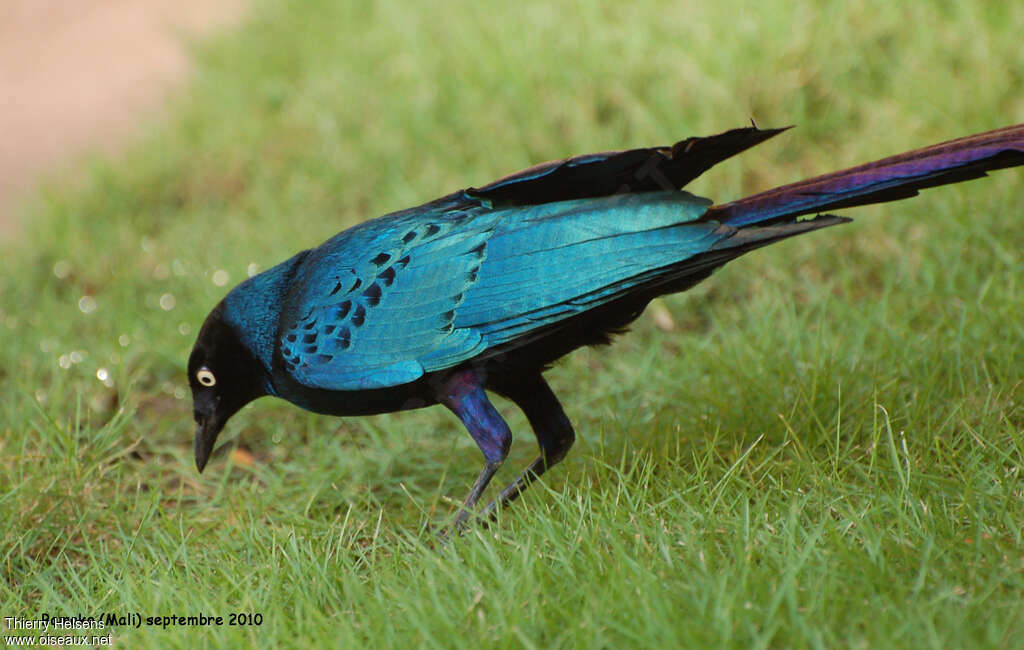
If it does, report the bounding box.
[280,212,494,390]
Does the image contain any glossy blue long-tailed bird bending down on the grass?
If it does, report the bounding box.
[187,121,1024,530]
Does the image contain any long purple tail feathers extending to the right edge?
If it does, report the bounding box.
[708,124,1024,227]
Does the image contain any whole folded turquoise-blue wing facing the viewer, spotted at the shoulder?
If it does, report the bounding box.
[280,191,726,390]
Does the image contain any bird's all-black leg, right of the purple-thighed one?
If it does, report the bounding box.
[482,374,575,521]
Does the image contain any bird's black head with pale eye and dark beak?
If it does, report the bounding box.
[188,303,266,472]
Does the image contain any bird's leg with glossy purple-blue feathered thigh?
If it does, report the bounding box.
[439,370,512,530]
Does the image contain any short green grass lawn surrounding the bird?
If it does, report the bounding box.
[0,0,1024,648]
